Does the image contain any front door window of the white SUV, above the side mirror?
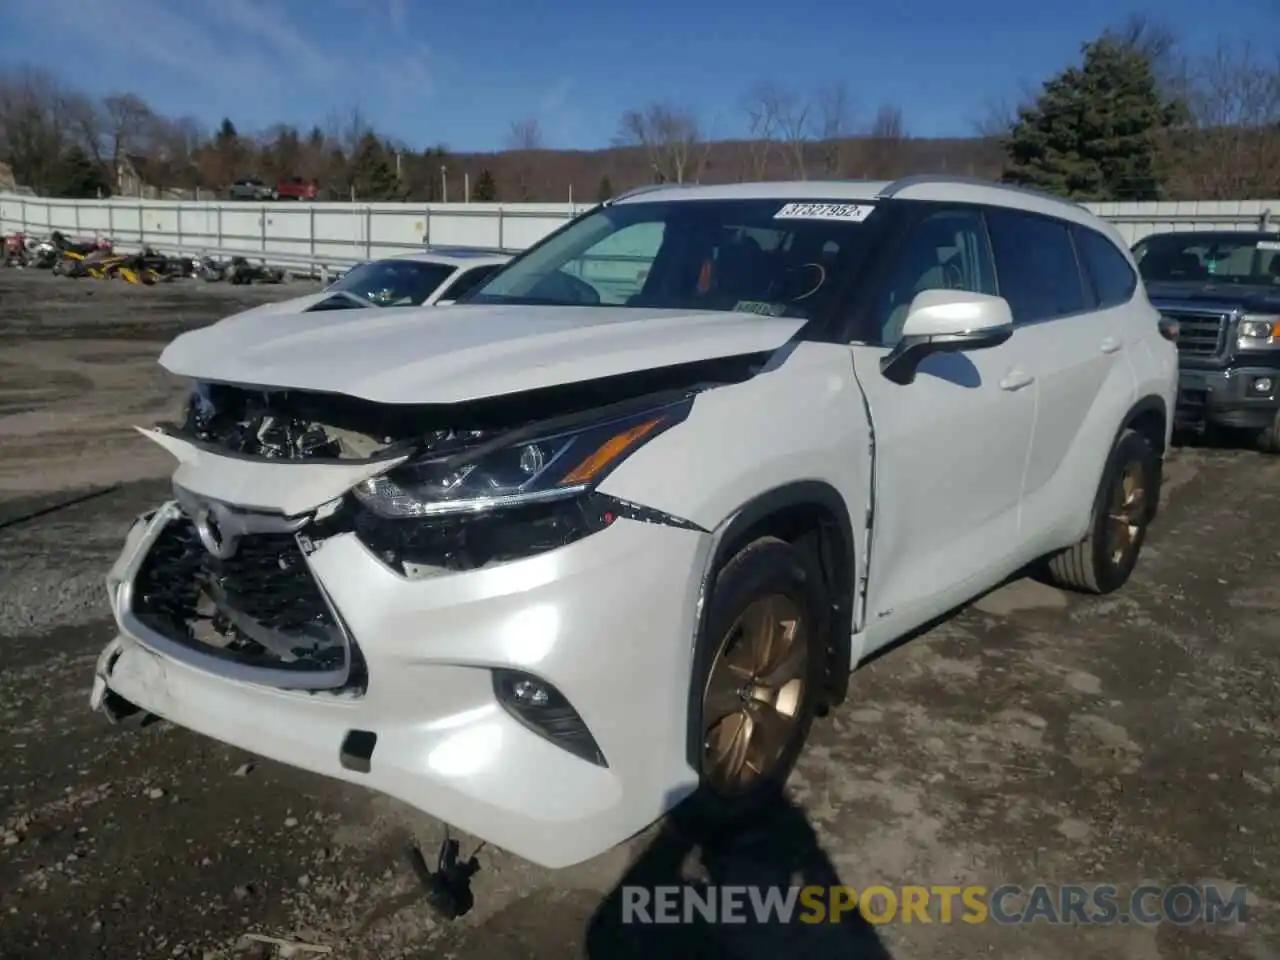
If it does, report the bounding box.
[876,210,997,346]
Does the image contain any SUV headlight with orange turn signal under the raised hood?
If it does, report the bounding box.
[352,398,692,518]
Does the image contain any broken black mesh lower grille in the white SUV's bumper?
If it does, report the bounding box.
[132,517,349,675]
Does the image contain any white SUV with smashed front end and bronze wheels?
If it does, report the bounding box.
[92,178,1178,867]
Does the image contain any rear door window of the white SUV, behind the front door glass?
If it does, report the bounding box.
[987,210,1091,324]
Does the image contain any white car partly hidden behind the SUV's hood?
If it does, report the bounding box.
[237,247,511,316]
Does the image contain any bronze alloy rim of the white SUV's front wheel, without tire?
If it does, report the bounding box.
[703,594,809,796]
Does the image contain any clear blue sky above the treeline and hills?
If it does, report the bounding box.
[0,0,1280,150]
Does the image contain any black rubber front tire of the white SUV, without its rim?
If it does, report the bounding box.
[680,538,829,833]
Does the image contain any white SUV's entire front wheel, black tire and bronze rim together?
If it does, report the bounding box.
[686,538,826,827]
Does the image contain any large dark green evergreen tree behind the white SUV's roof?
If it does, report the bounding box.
[1004,36,1178,201]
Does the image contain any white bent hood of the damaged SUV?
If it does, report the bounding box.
[160,305,804,403]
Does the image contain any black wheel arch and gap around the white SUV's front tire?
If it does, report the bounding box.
[685,480,858,769]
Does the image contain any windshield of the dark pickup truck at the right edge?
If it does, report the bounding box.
[1133,233,1280,285]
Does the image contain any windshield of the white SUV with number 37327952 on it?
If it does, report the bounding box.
[466,200,873,320]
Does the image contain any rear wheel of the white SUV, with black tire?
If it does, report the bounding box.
[1047,430,1161,594]
